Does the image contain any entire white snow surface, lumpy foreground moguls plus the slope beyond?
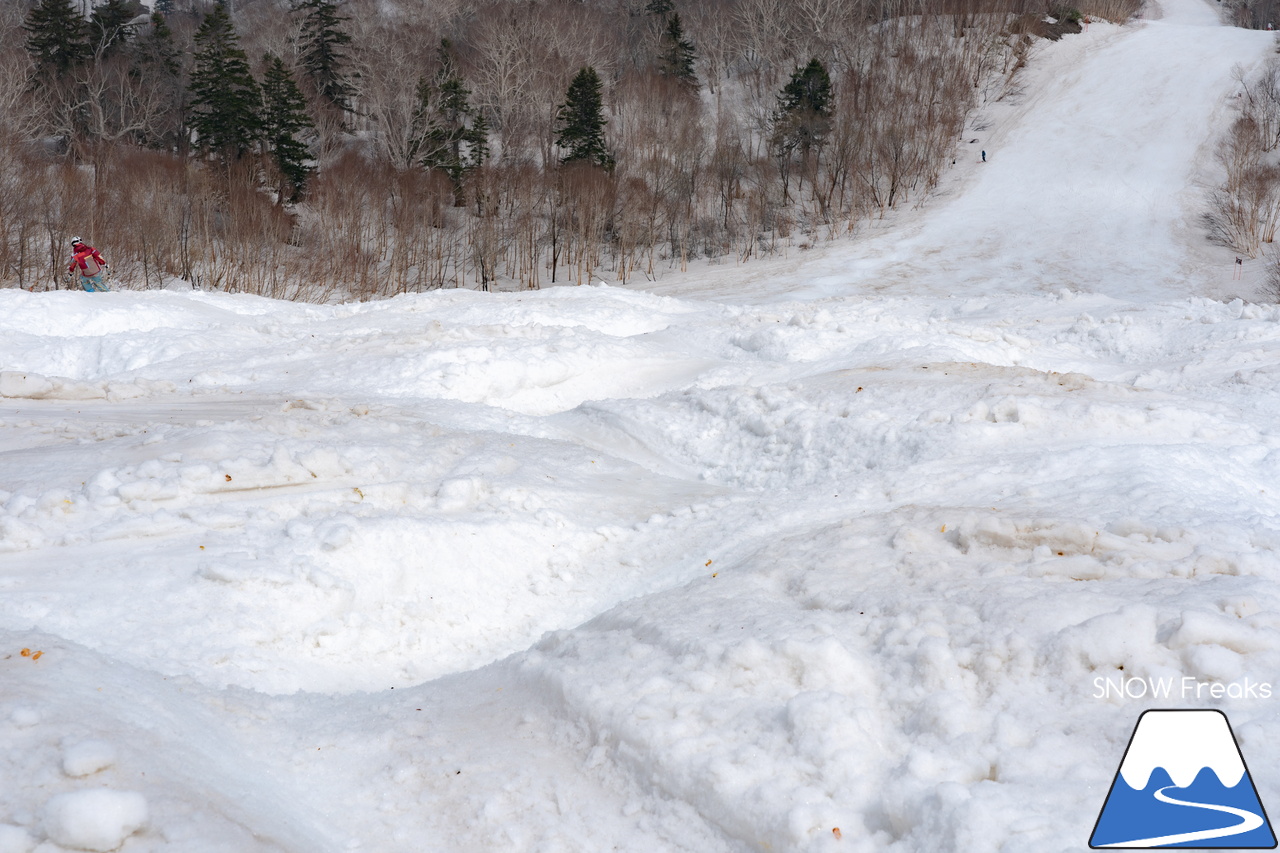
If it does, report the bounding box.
[0,0,1280,853]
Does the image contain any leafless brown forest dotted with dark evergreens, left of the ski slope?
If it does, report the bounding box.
[0,0,1152,301]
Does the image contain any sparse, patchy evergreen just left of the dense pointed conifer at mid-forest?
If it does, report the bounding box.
[419,38,489,192]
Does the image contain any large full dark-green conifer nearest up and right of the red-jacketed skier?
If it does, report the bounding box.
[191,3,262,161]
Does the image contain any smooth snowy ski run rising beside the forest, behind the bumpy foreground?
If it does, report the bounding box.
[655,0,1274,301]
